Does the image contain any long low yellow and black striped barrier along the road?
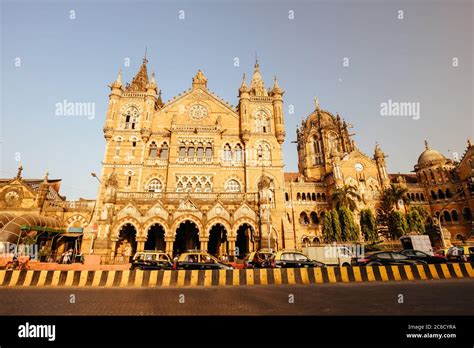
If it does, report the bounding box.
[0,263,474,288]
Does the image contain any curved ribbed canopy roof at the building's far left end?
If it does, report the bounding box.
[0,214,64,243]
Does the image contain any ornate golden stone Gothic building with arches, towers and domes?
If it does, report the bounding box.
[0,58,474,259]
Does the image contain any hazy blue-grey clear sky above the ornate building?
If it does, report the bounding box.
[0,0,474,199]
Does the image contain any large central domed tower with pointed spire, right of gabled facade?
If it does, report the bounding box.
[296,98,354,181]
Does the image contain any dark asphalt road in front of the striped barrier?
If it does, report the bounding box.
[0,279,474,315]
